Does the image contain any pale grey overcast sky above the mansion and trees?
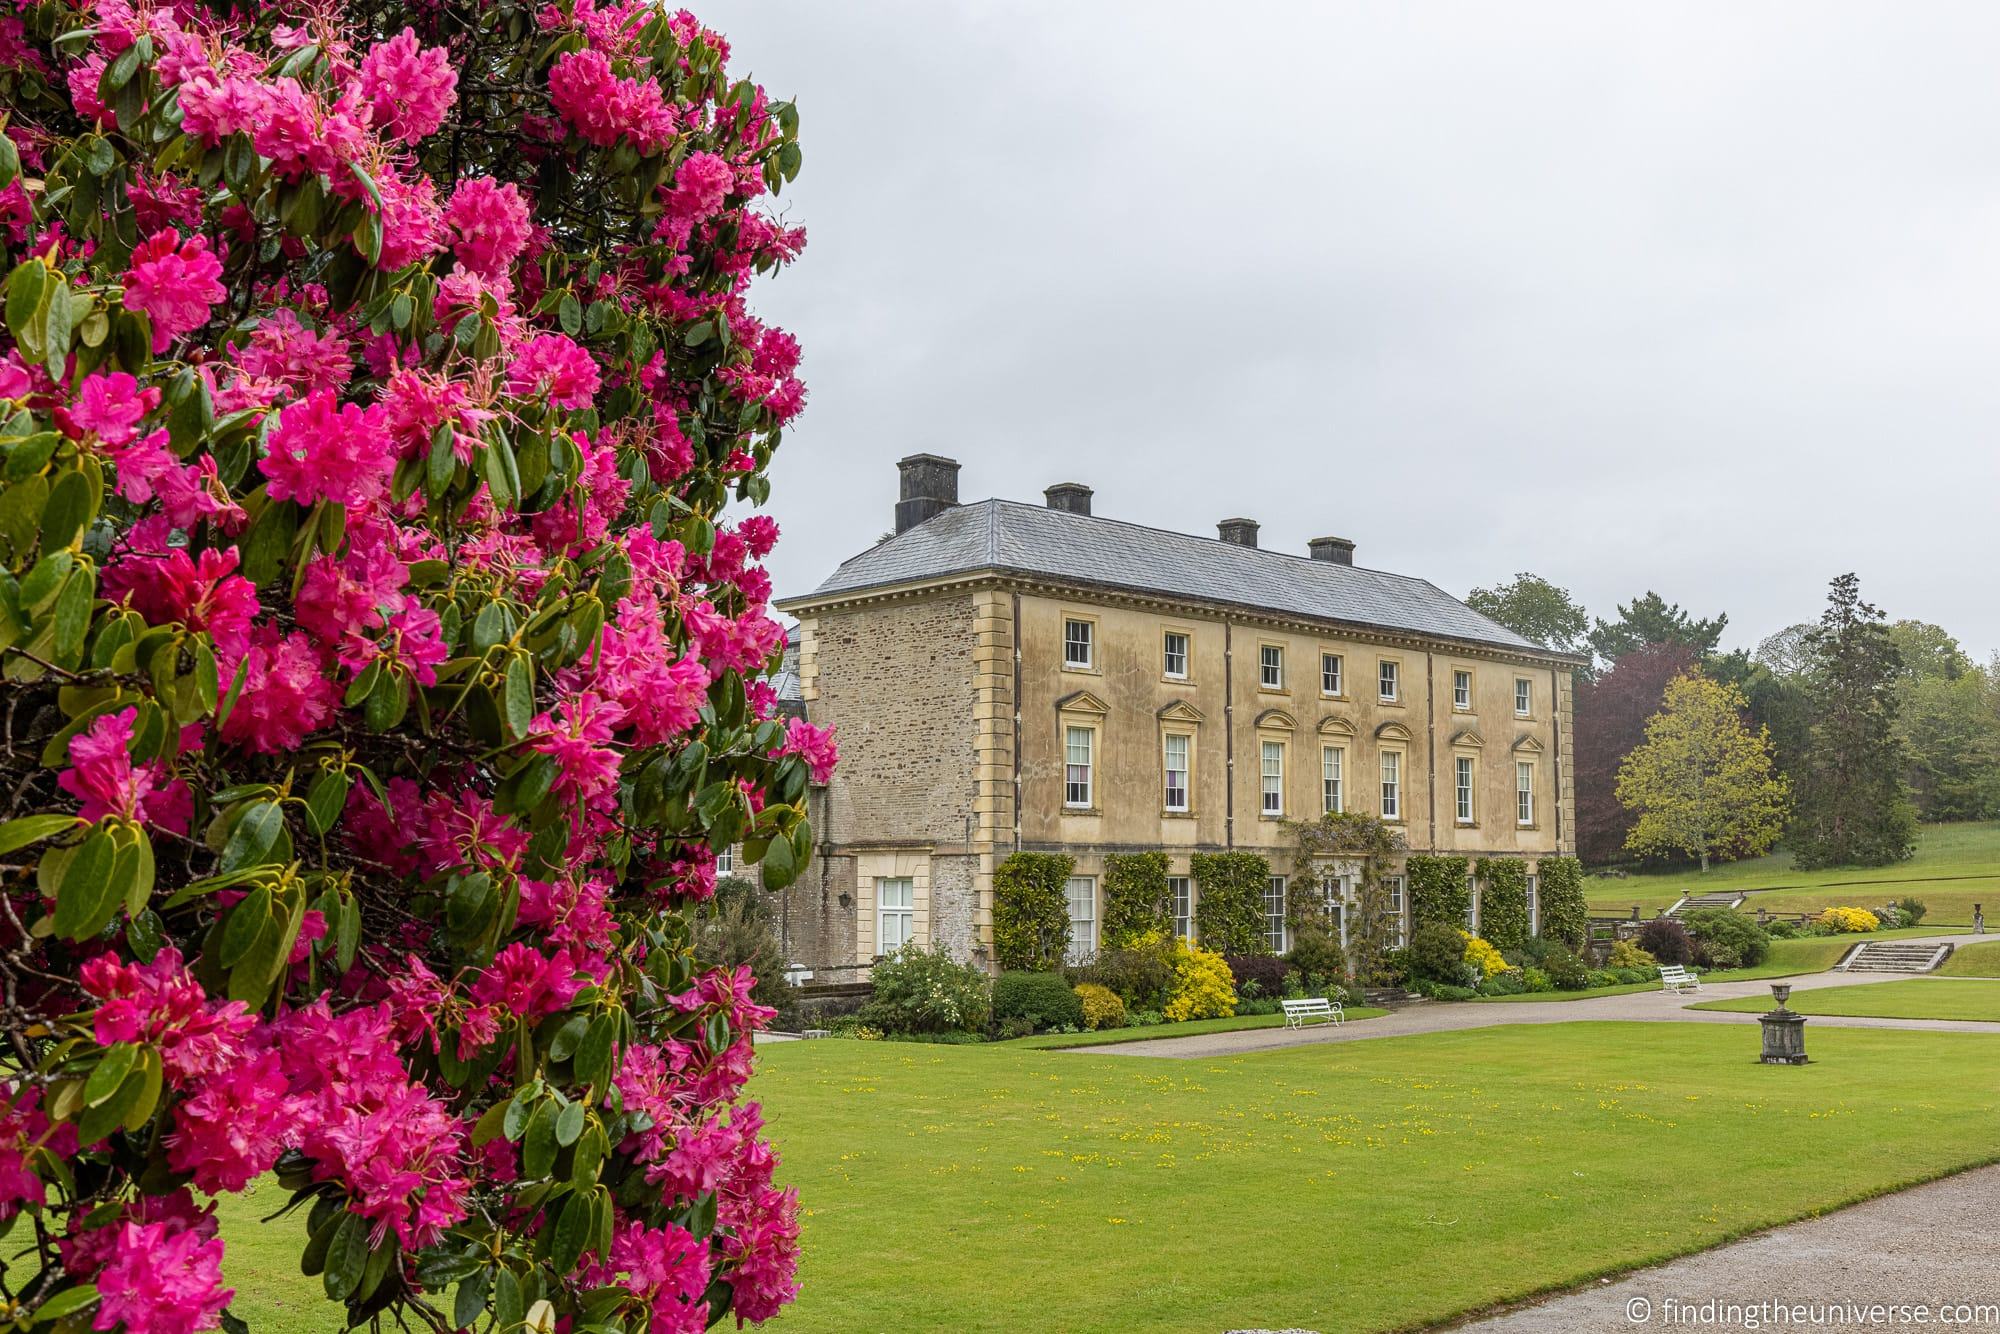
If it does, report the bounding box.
[698,0,2000,656]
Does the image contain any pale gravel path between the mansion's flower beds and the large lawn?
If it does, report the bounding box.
[1068,936,2000,1060]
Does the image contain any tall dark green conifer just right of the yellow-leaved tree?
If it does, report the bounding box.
[1790,574,1916,868]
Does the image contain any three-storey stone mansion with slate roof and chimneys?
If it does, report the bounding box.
[778,464,1576,980]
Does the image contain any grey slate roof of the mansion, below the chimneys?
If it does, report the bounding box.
[780,500,1550,654]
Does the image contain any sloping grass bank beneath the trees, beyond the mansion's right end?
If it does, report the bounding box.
[1584,820,2000,926]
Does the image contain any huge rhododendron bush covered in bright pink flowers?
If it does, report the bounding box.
[0,0,834,1334]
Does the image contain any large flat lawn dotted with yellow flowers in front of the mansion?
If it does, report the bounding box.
[224,1024,2000,1334]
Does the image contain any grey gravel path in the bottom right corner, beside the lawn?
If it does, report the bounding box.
[1458,1166,2000,1334]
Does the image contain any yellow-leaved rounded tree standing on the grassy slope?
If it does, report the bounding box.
[1618,672,1788,872]
